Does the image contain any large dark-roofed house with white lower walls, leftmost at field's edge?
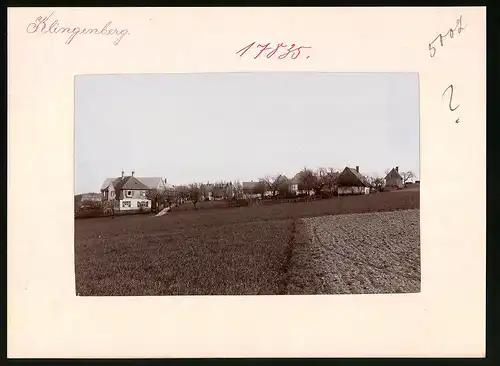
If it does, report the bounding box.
[101,172,168,211]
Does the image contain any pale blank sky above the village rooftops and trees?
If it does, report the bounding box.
[75,72,420,193]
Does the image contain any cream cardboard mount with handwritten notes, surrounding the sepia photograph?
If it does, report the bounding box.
[8,7,486,357]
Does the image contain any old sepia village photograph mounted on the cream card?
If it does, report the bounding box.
[74,72,421,296]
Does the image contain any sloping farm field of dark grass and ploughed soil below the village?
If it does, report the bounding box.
[75,190,420,296]
